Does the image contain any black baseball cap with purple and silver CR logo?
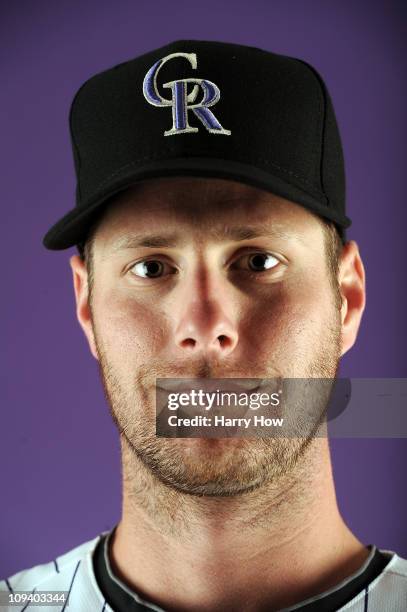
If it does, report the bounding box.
[43,40,351,250]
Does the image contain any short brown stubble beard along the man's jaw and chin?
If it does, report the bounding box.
[92,304,341,497]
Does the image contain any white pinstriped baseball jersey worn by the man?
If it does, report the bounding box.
[0,532,407,612]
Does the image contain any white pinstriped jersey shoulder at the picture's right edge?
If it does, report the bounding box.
[341,550,407,612]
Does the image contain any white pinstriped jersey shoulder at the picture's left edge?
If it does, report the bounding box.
[0,532,109,612]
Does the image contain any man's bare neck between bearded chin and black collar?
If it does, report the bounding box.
[110,438,368,611]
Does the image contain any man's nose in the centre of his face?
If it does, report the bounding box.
[175,298,238,357]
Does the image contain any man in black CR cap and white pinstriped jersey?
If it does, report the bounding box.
[1,41,407,612]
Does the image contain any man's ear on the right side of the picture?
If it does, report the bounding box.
[338,240,366,356]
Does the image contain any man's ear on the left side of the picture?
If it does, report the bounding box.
[69,255,99,359]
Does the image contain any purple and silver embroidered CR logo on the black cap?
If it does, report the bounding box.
[143,53,231,136]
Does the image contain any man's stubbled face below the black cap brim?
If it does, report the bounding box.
[77,178,348,495]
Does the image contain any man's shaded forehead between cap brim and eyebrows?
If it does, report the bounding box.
[97,177,320,244]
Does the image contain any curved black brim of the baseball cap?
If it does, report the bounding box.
[43,157,351,250]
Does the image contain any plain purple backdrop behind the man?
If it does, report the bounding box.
[0,0,407,577]
